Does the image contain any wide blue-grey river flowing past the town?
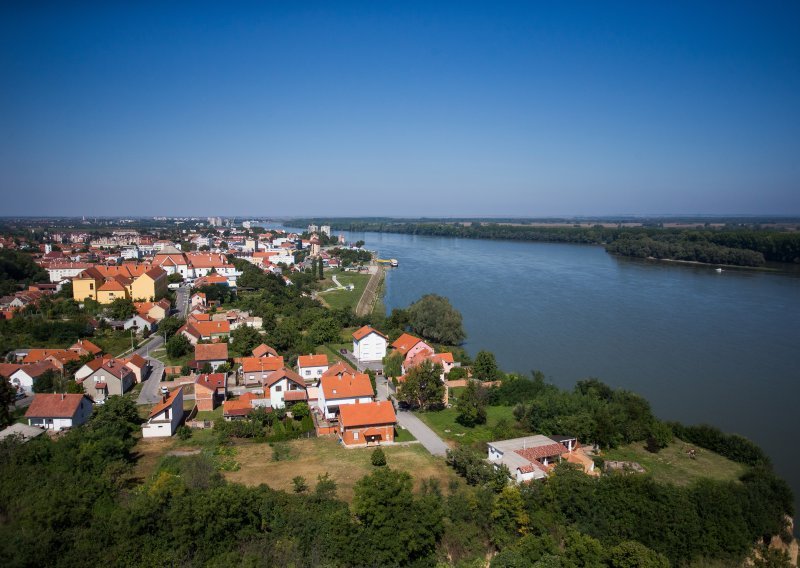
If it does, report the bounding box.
[334,229,800,510]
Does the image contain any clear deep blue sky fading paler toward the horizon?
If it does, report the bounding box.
[0,0,800,216]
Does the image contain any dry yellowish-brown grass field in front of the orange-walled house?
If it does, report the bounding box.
[225,437,458,501]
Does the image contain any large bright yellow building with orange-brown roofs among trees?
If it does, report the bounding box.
[72,264,167,304]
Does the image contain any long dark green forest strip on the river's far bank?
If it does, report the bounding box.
[298,220,800,266]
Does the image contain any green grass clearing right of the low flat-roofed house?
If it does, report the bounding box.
[602,439,745,485]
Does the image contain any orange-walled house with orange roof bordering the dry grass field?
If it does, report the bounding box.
[339,400,397,447]
